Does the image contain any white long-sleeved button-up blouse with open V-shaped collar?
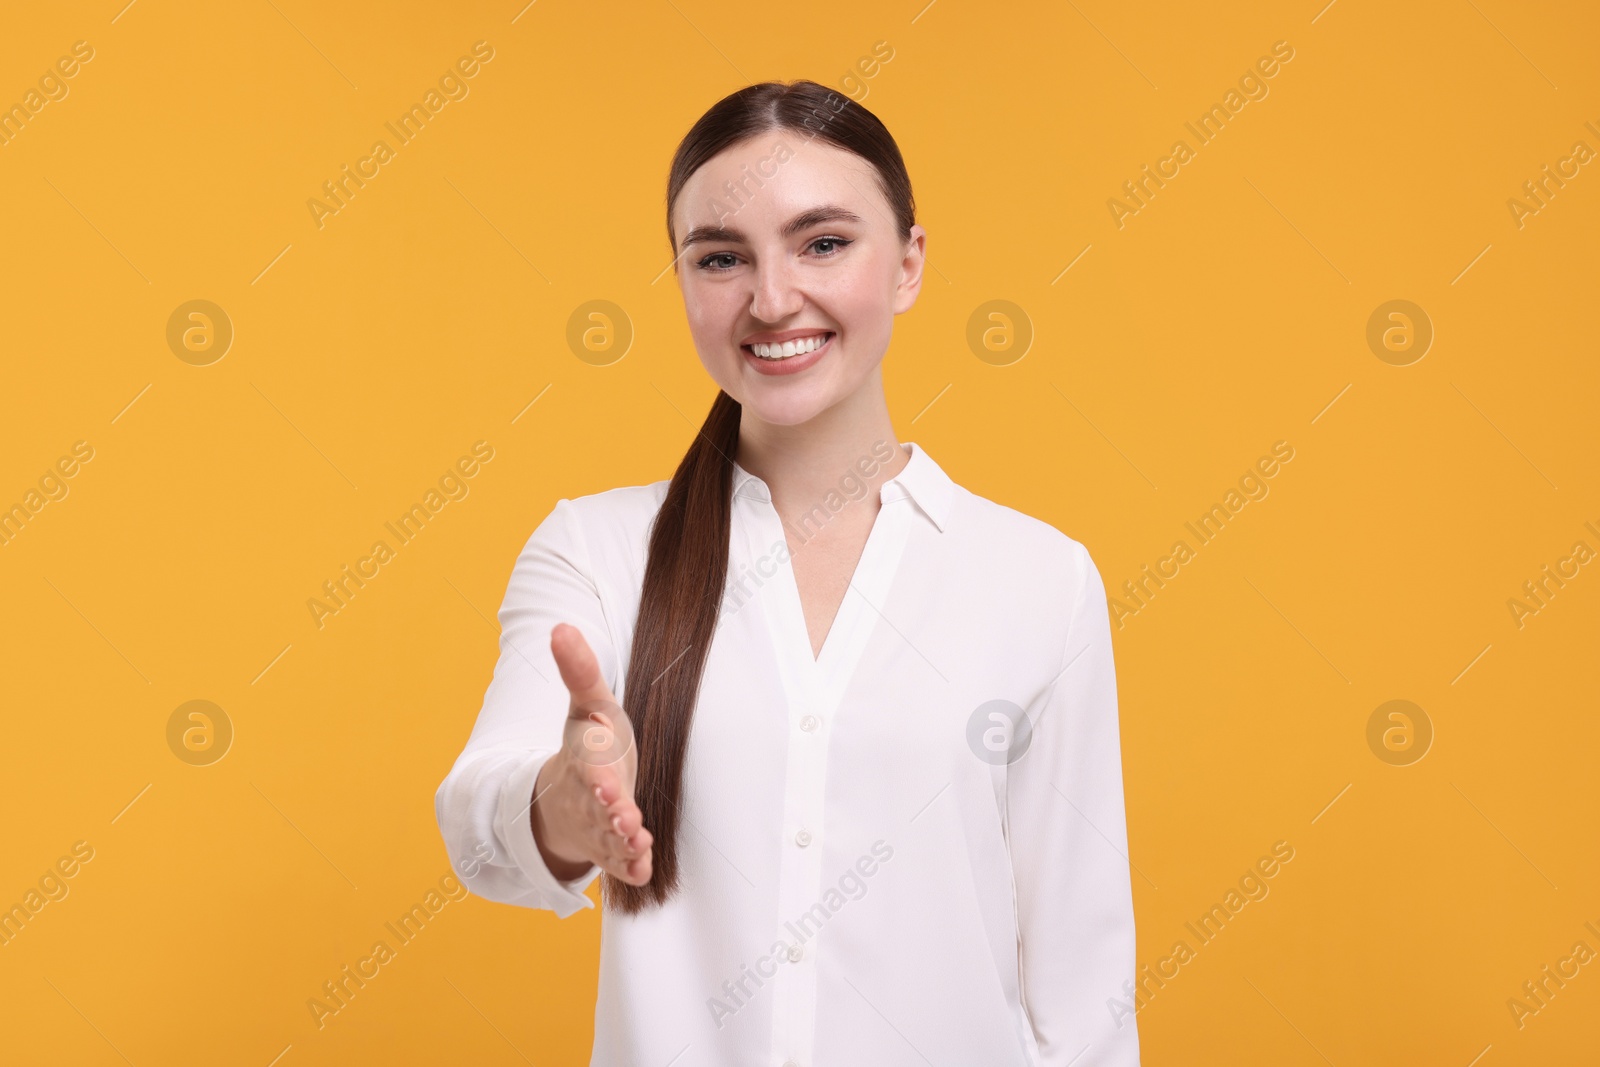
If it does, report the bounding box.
[435,443,1139,1067]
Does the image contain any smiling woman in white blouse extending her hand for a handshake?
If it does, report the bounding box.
[437,82,1139,1067]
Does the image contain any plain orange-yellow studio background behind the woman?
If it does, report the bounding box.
[0,0,1600,1067]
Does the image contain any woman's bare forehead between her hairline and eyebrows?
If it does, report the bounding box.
[672,130,888,240]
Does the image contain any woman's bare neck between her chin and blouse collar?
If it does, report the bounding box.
[736,368,910,526]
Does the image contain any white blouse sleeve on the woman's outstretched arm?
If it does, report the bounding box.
[434,499,618,918]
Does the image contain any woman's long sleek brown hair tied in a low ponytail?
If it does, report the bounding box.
[603,80,915,913]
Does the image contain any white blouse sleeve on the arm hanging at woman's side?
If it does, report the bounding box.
[1006,542,1139,1067]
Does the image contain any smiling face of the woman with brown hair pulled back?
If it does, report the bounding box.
[672,130,926,426]
